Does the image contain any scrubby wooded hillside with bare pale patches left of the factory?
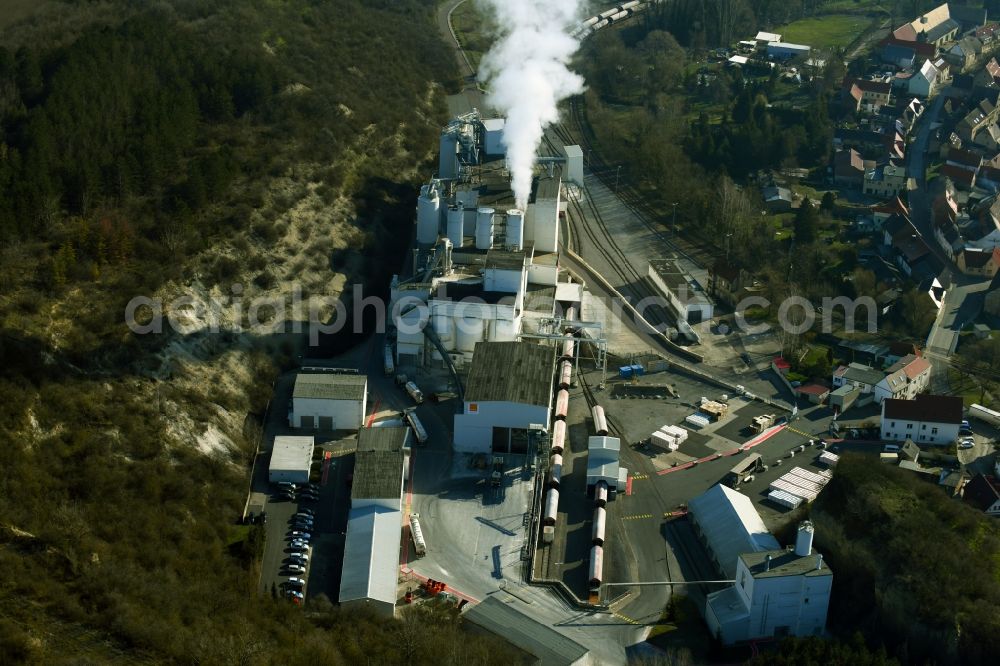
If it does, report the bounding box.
[0,0,510,664]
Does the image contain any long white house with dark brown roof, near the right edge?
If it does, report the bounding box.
[882,393,962,446]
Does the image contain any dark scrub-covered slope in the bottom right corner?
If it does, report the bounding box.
[811,455,1000,664]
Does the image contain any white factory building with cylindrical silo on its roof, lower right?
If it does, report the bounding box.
[705,522,833,645]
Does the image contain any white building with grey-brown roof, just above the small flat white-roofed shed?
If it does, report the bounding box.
[288,372,368,430]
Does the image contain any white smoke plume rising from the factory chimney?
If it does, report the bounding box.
[479,0,583,210]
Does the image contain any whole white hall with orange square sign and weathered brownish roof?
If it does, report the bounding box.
[455,342,555,453]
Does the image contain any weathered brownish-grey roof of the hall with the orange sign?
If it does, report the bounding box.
[465,342,555,407]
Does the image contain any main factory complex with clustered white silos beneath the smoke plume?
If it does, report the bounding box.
[391,111,583,367]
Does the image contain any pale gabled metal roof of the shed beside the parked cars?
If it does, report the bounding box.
[340,507,403,604]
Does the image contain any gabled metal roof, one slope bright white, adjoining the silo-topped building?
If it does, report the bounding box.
[688,484,781,578]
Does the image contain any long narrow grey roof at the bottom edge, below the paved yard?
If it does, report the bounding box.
[462,597,587,666]
